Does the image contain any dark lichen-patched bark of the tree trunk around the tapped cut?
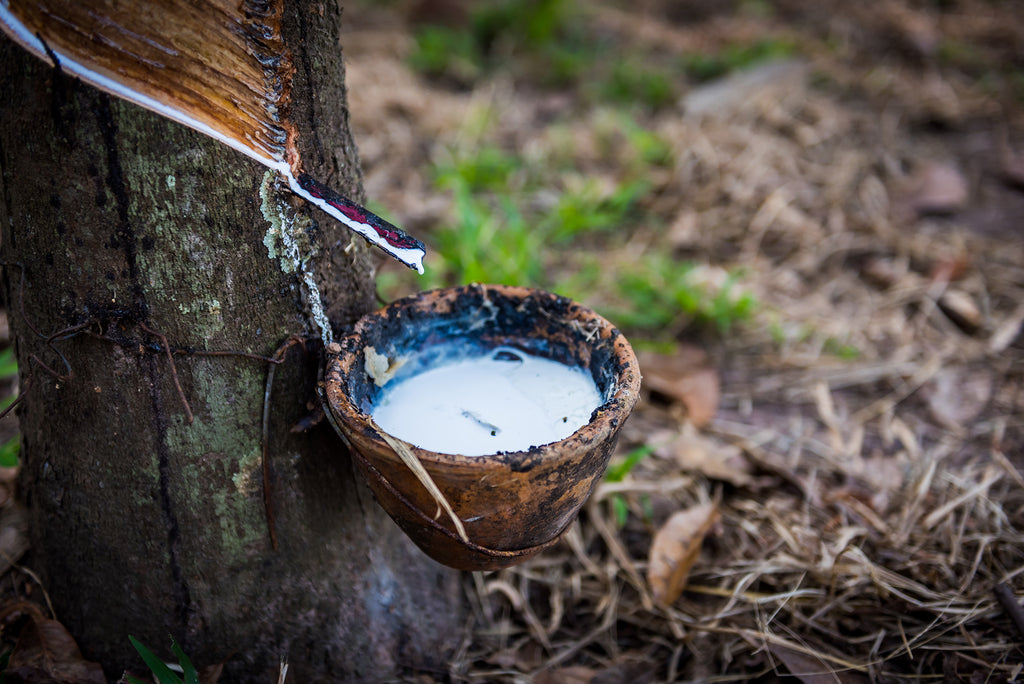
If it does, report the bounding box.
[0,2,462,682]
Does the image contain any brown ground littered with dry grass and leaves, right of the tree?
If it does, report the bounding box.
[343,0,1024,683]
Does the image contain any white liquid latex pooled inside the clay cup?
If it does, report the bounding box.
[372,347,602,456]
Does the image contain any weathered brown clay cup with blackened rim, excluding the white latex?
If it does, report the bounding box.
[325,285,640,570]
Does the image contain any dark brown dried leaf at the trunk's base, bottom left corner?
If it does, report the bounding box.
[5,613,106,684]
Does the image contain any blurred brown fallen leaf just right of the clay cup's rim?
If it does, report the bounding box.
[639,345,722,427]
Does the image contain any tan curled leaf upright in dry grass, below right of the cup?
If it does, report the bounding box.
[647,503,719,605]
